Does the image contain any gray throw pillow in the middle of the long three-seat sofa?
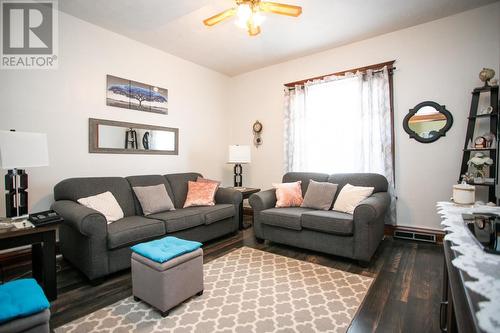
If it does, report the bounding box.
[132,184,175,215]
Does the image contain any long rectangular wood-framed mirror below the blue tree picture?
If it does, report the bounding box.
[89,118,179,155]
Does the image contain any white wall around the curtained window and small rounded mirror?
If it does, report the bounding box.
[230,2,500,229]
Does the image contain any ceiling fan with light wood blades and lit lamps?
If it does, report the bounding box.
[203,0,302,36]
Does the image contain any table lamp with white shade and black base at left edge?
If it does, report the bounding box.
[0,130,49,217]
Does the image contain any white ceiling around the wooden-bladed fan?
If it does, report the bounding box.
[59,0,497,76]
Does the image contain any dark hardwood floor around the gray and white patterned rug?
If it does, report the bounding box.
[3,217,443,333]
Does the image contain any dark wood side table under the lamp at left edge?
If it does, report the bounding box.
[0,223,57,301]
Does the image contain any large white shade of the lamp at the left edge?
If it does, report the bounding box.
[0,131,49,169]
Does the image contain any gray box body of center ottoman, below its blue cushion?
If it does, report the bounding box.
[131,237,203,317]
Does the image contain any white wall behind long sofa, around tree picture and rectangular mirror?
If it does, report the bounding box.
[0,13,231,215]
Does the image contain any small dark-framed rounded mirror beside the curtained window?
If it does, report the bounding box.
[403,101,453,143]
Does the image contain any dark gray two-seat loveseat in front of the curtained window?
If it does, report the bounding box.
[249,172,391,265]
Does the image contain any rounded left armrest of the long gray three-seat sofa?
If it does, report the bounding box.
[52,200,108,237]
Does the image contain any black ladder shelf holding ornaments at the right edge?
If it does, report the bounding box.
[458,85,499,202]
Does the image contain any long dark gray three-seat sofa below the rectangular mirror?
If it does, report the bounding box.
[52,173,242,282]
